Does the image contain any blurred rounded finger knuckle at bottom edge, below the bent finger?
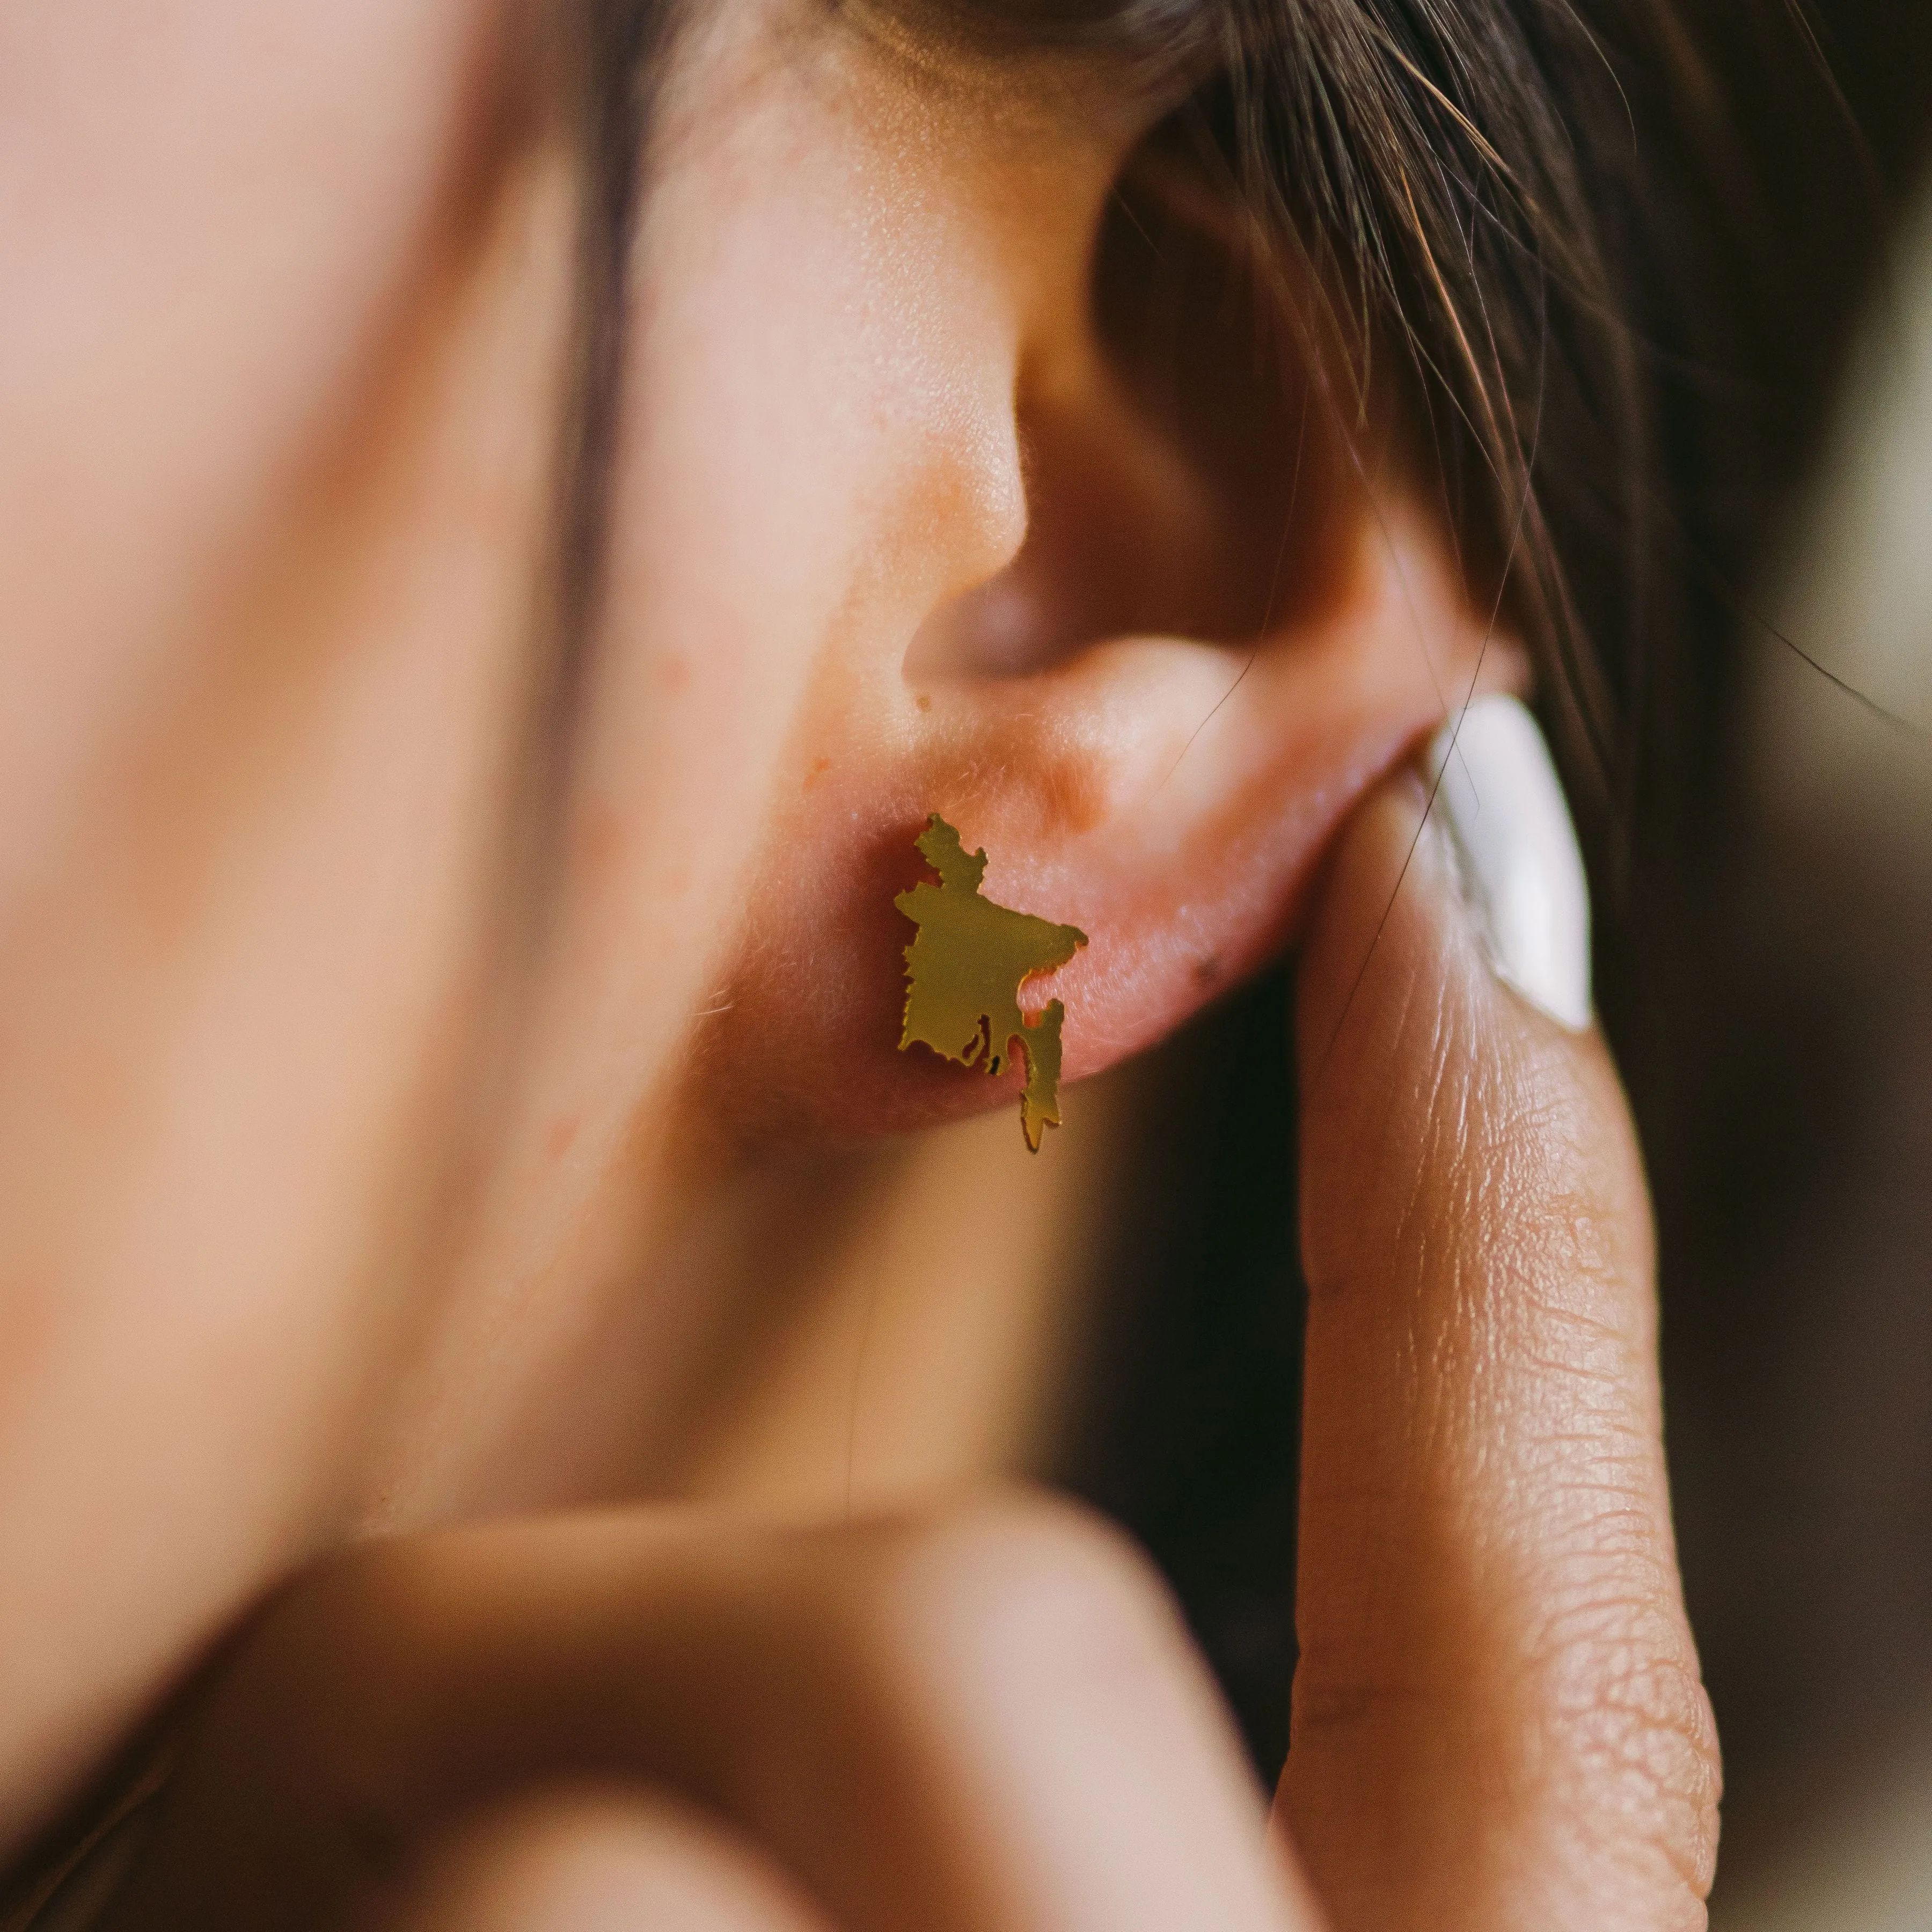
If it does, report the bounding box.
[360,1787,827,1932]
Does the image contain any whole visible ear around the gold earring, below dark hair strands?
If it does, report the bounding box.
[595,30,1520,1140]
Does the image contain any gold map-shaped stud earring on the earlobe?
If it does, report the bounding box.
[892,811,1086,1153]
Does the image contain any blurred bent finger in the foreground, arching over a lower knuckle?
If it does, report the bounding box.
[106,1503,1308,1932]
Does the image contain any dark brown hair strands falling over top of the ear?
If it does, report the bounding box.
[877,0,1777,889]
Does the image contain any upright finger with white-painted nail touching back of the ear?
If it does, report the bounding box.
[1279,699,1717,1932]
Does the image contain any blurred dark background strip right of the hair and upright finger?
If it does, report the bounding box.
[1633,0,1932,1932]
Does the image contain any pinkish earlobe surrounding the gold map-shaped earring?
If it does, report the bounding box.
[707,500,1526,1138]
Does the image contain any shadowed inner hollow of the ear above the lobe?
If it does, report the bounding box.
[906,160,1346,682]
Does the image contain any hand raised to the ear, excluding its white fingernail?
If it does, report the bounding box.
[98,703,1717,1932]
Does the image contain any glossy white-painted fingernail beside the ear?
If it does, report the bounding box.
[1424,698,1590,1031]
